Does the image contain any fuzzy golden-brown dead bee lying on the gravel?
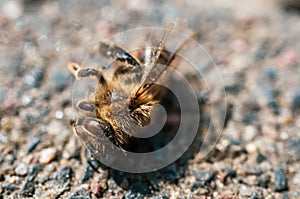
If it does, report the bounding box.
[68,23,192,154]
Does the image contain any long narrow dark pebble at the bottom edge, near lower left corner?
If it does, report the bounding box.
[21,164,41,197]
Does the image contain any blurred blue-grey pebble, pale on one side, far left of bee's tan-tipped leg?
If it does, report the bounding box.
[23,67,45,89]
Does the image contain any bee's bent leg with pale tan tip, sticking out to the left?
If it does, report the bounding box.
[68,62,106,85]
